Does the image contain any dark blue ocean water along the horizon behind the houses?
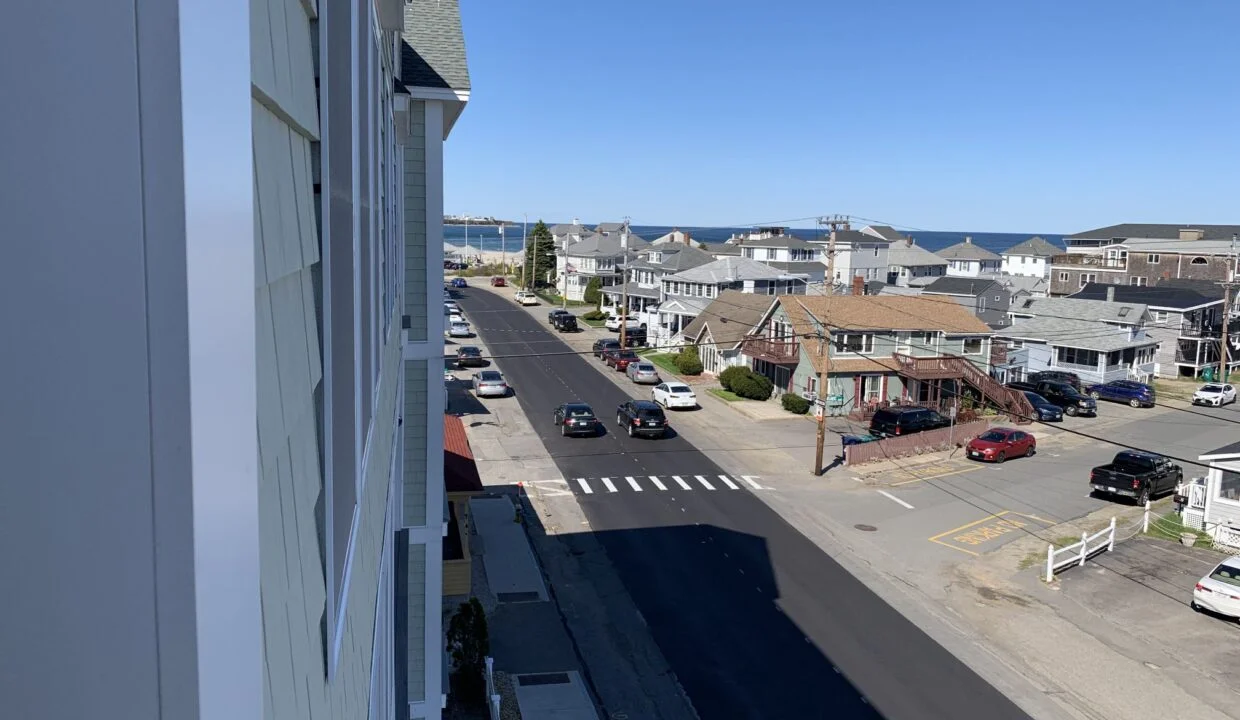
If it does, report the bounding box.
[444,226,1064,260]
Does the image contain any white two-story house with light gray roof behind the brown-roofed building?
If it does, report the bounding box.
[647,257,808,345]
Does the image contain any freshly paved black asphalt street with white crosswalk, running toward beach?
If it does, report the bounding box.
[456,285,1027,720]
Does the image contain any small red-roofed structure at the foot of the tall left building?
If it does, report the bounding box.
[443,413,484,604]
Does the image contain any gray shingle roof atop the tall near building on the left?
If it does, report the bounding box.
[401,0,470,90]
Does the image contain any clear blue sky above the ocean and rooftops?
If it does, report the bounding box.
[445,0,1240,232]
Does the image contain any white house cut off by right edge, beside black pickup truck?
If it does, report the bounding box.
[1180,442,1240,554]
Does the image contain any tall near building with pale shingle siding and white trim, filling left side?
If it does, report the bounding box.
[0,0,471,720]
